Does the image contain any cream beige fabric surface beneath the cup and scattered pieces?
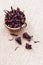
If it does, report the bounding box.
[0,0,43,65]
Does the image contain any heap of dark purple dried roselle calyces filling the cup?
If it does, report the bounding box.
[4,6,26,28]
